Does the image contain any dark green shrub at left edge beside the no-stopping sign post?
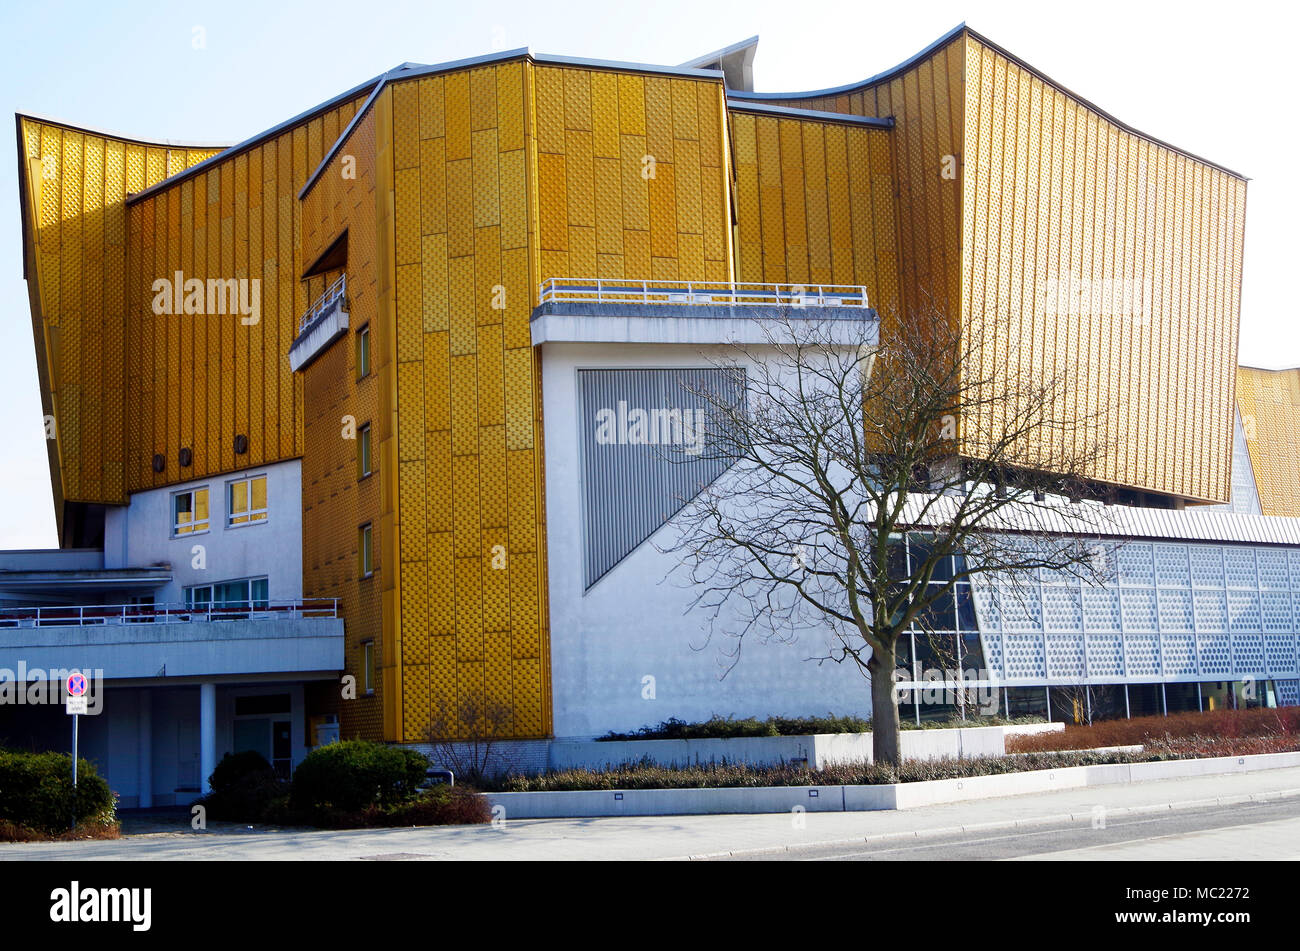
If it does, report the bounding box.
[0,750,117,837]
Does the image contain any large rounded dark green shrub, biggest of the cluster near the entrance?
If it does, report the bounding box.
[290,739,429,815]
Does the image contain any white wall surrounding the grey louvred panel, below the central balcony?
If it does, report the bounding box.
[542,343,871,737]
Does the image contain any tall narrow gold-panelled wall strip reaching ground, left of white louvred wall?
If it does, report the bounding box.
[385,61,550,742]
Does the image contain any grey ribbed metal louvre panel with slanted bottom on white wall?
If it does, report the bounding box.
[579,368,745,589]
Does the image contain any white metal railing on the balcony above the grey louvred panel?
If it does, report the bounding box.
[538,278,868,308]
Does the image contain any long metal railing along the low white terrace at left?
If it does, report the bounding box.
[0,598,338,628]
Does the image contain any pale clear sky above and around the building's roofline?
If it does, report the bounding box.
[0,0,1300,548]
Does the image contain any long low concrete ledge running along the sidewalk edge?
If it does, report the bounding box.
[488,752,1300,818]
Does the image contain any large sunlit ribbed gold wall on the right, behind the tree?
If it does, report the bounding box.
[962,36,1245,501]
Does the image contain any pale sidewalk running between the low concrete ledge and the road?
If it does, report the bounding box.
[10,768,1300,861]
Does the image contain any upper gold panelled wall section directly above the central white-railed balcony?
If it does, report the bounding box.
[532,66,732,281]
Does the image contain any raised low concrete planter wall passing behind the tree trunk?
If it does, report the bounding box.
[549,724,1065,770]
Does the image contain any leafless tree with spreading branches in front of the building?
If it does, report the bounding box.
[660,311,1113,763]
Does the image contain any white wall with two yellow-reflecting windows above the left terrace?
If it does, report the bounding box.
[104,460,303,603]
